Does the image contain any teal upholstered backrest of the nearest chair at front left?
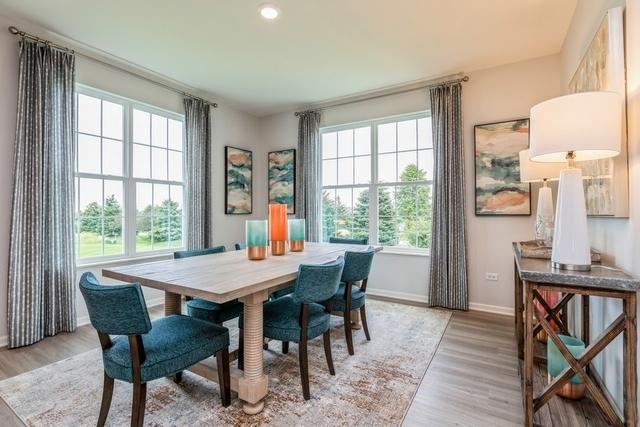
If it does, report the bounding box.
[80,273,151,335]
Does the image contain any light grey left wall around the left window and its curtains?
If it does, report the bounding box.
[0,16,267,346]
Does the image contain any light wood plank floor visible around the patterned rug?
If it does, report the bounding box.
[0,307,522,427]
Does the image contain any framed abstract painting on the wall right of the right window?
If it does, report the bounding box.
[474,119,531,216]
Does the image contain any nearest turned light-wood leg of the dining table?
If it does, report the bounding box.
[238,291,269,415]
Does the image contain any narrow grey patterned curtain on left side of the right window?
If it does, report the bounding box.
[295,111,322,242]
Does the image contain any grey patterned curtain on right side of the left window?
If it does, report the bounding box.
[184,98,212,250]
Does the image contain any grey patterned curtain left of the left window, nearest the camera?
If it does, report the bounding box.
[8,39,76,348]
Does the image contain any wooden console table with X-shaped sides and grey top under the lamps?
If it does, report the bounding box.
[513,243,640,426]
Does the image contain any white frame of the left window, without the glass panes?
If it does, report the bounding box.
[73,83,186,267]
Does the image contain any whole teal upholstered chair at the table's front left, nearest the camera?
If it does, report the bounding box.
[80,273,231,427]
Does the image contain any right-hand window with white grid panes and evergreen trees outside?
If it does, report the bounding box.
[321,114,433,249]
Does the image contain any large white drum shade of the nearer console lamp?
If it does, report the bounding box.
[529,92,623,162]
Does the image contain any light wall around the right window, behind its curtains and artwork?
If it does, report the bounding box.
[260,55,562,313]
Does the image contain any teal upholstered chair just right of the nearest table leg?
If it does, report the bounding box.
[239,257,344,400]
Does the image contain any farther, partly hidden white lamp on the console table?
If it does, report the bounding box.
[519,149,564,245]
